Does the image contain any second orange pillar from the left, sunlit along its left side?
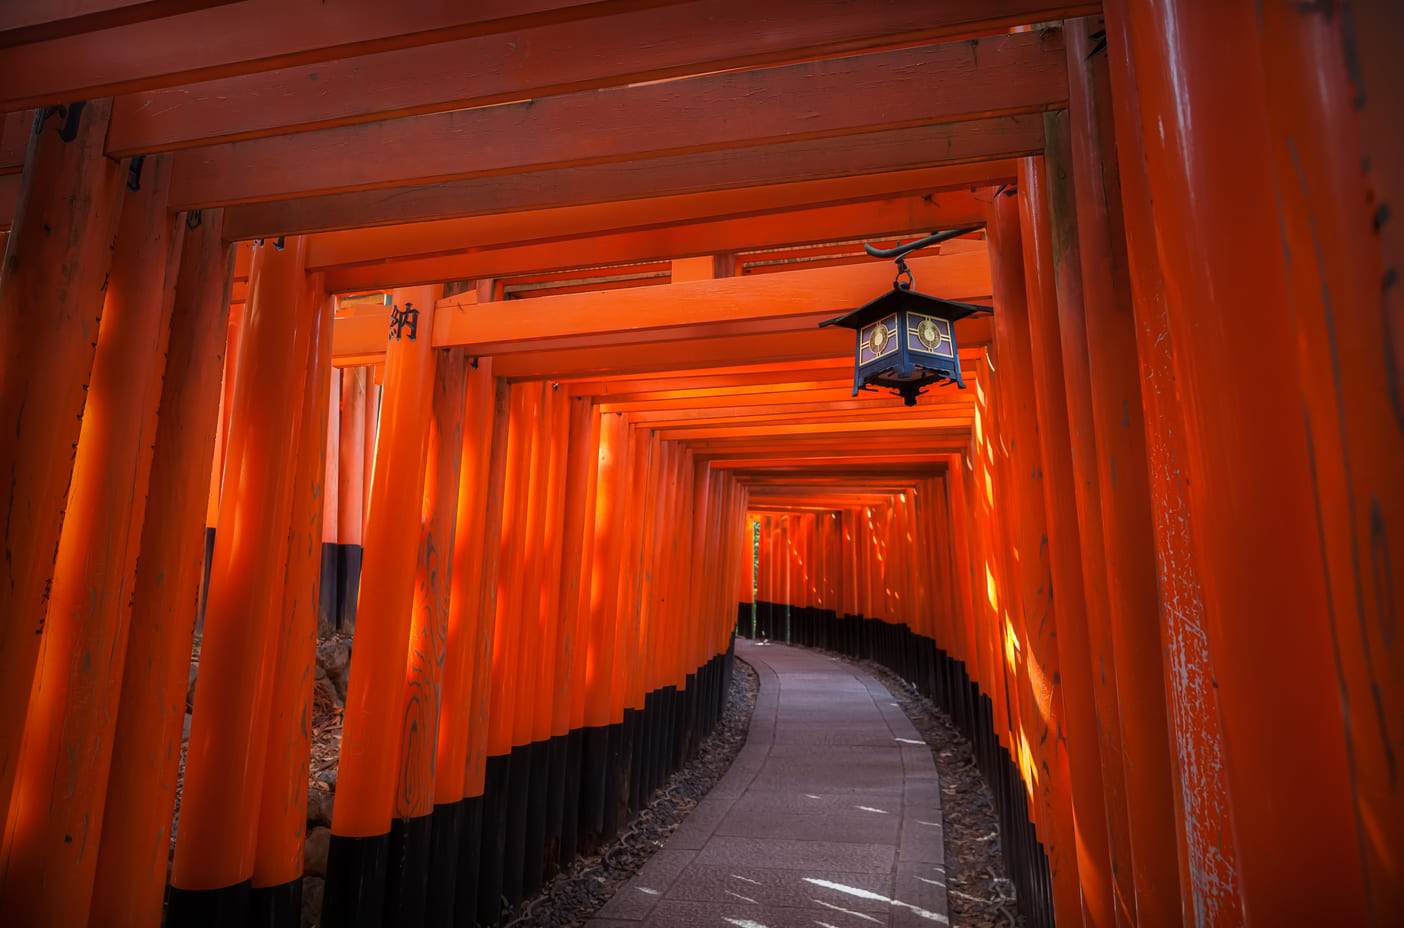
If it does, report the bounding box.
[0,159,183,925]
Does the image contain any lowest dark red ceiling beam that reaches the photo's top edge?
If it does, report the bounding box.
[107,0,1098,154]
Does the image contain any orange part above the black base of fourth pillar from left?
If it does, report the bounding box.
[171,239,314,891]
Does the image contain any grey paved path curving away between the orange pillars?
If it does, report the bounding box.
[588,640,949,928]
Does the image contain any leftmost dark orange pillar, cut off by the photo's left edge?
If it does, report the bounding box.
[0,101,125,847]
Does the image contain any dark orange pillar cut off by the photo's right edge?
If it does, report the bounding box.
[1258,4,1404,925]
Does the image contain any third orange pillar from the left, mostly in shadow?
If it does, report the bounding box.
[88,211,233,928]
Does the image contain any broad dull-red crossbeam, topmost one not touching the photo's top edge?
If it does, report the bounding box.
[171,29,1067,206]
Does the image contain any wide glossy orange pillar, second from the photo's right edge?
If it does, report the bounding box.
[1108,0,1367,925]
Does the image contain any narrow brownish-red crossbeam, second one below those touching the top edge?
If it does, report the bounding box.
[225,155,1022,239]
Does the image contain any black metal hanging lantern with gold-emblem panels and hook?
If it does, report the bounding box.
[820,229,994,406]
